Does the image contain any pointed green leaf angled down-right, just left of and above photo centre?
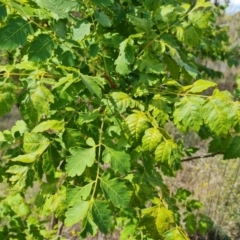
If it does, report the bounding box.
[81,74,104,98]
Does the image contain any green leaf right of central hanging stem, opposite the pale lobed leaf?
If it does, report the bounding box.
[103,147,130,174]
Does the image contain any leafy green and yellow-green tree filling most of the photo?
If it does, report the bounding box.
[0,0,240,240]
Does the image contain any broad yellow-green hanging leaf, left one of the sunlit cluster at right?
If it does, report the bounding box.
[173,96,204,132]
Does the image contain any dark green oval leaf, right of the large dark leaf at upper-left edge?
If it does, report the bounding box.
[28,34,55,62]
